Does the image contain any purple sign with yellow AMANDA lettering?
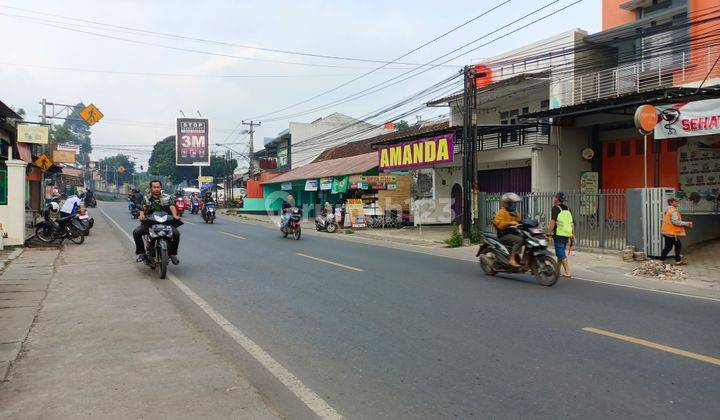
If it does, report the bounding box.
[378,133,455,171]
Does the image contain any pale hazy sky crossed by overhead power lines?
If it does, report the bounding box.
[0,0,601,168]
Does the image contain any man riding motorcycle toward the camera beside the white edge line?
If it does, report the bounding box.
[133,179,180,265]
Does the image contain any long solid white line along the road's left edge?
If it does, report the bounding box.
[98,209,343,419]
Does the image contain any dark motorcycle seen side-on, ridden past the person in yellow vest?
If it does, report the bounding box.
[476,219,560,286]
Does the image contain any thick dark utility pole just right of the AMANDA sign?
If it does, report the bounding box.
[462,66,477,238]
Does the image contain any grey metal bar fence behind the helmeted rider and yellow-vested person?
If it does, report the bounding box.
[478,190,627,250]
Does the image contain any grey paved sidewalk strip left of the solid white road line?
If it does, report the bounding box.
[0,217,278,419]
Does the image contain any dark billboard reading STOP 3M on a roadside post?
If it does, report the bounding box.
[175,118,210,166]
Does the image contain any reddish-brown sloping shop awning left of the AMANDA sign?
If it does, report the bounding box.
[264,152,378,184]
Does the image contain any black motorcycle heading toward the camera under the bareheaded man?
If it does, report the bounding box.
[142,211,183,279]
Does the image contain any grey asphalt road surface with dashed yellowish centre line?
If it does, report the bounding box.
[101,203,720,419]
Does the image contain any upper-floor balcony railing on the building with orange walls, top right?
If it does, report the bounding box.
[550,45,720,108]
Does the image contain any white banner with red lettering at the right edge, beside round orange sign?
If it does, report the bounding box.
[655,99,720,140]
